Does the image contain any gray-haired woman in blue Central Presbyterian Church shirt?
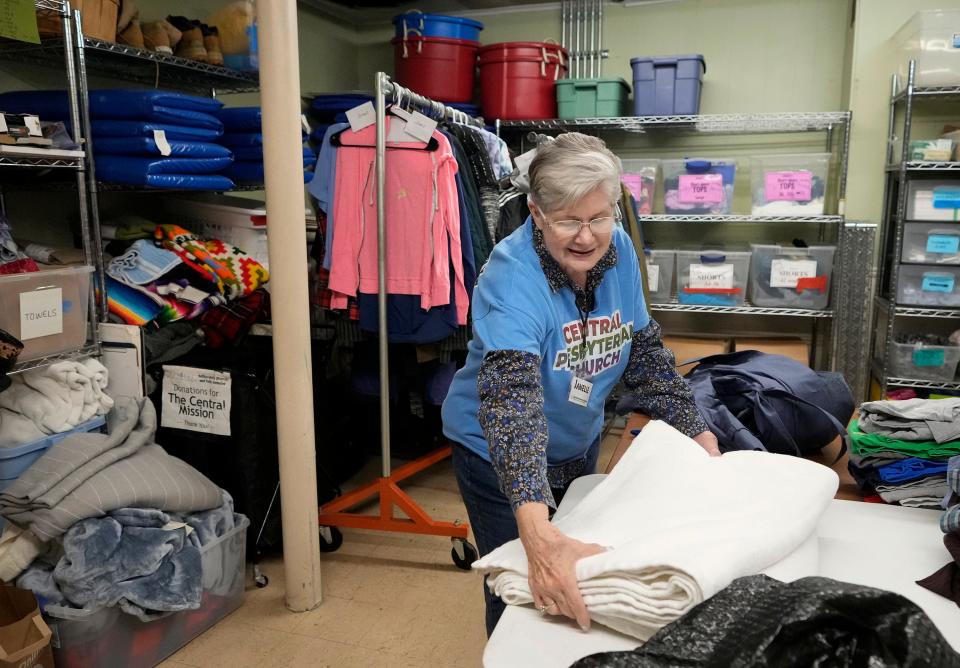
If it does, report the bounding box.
[443,133,719,635]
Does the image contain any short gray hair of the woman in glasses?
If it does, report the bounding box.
[529,132,622,211]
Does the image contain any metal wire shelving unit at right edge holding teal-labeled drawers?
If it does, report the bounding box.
[871,61,960,396]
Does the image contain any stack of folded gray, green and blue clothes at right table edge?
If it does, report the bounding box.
[848,398,960,509]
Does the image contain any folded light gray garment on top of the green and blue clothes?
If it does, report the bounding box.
[860,397,960,443]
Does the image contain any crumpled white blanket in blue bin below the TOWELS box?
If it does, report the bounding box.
[0,358,113,434]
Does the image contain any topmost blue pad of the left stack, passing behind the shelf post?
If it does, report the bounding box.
[0,89,223,131]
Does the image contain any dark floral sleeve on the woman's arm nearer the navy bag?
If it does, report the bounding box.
[617,319,707,437]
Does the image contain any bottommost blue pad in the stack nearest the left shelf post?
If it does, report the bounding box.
[96,155,234,190]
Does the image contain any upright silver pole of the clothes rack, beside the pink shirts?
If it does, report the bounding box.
[374,72,390,478]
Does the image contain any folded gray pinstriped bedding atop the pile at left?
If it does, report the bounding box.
[0,398,223,540]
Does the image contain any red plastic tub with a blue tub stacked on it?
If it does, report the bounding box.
[391,35,480,102]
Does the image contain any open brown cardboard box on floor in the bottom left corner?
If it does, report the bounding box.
[0,587,53,668]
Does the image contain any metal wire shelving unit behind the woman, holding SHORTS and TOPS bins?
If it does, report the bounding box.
[495,111,876,399]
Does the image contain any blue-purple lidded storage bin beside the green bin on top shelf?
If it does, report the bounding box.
[630,55,707,116]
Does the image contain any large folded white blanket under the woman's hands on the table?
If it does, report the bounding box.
[473,422,839,640]
